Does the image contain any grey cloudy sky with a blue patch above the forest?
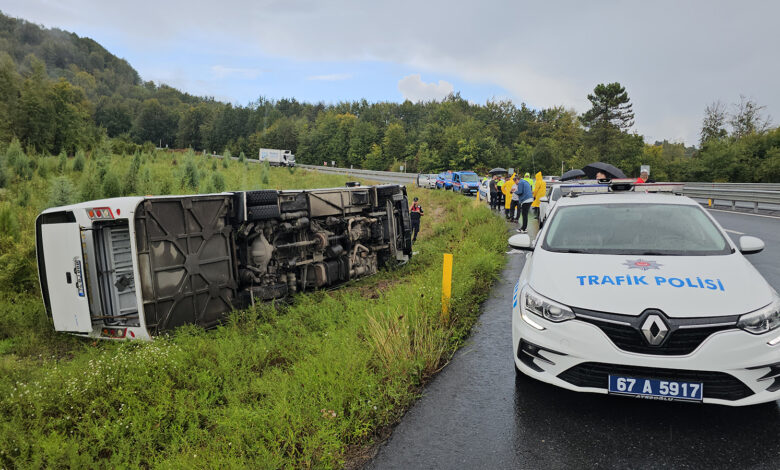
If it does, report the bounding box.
[0,0,780,145]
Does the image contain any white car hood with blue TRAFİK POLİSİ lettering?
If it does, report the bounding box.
[527,249,772,318]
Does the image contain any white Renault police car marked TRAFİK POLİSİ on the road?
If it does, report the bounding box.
[509,182,780,406]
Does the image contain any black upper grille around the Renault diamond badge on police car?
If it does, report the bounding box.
[573,309,737,356]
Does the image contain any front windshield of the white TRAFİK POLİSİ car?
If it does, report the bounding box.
[542,204,731,256]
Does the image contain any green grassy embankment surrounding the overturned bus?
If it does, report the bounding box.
[0,146,506,468]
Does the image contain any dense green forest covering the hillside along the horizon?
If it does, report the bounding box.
[0,14,780,182]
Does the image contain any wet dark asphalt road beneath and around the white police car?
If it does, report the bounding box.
[366,212,780,469]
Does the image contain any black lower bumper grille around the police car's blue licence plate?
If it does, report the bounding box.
[558,362,753,401]
